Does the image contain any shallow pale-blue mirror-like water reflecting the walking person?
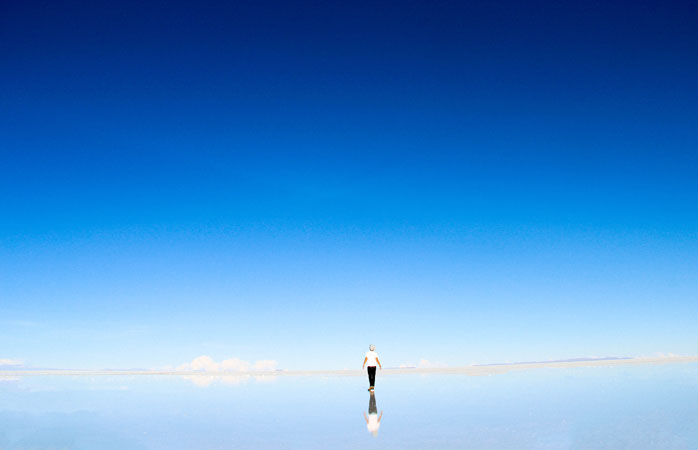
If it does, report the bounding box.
[0,364,698,450]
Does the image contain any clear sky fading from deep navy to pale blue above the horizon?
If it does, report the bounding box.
[0,1,698,369]
